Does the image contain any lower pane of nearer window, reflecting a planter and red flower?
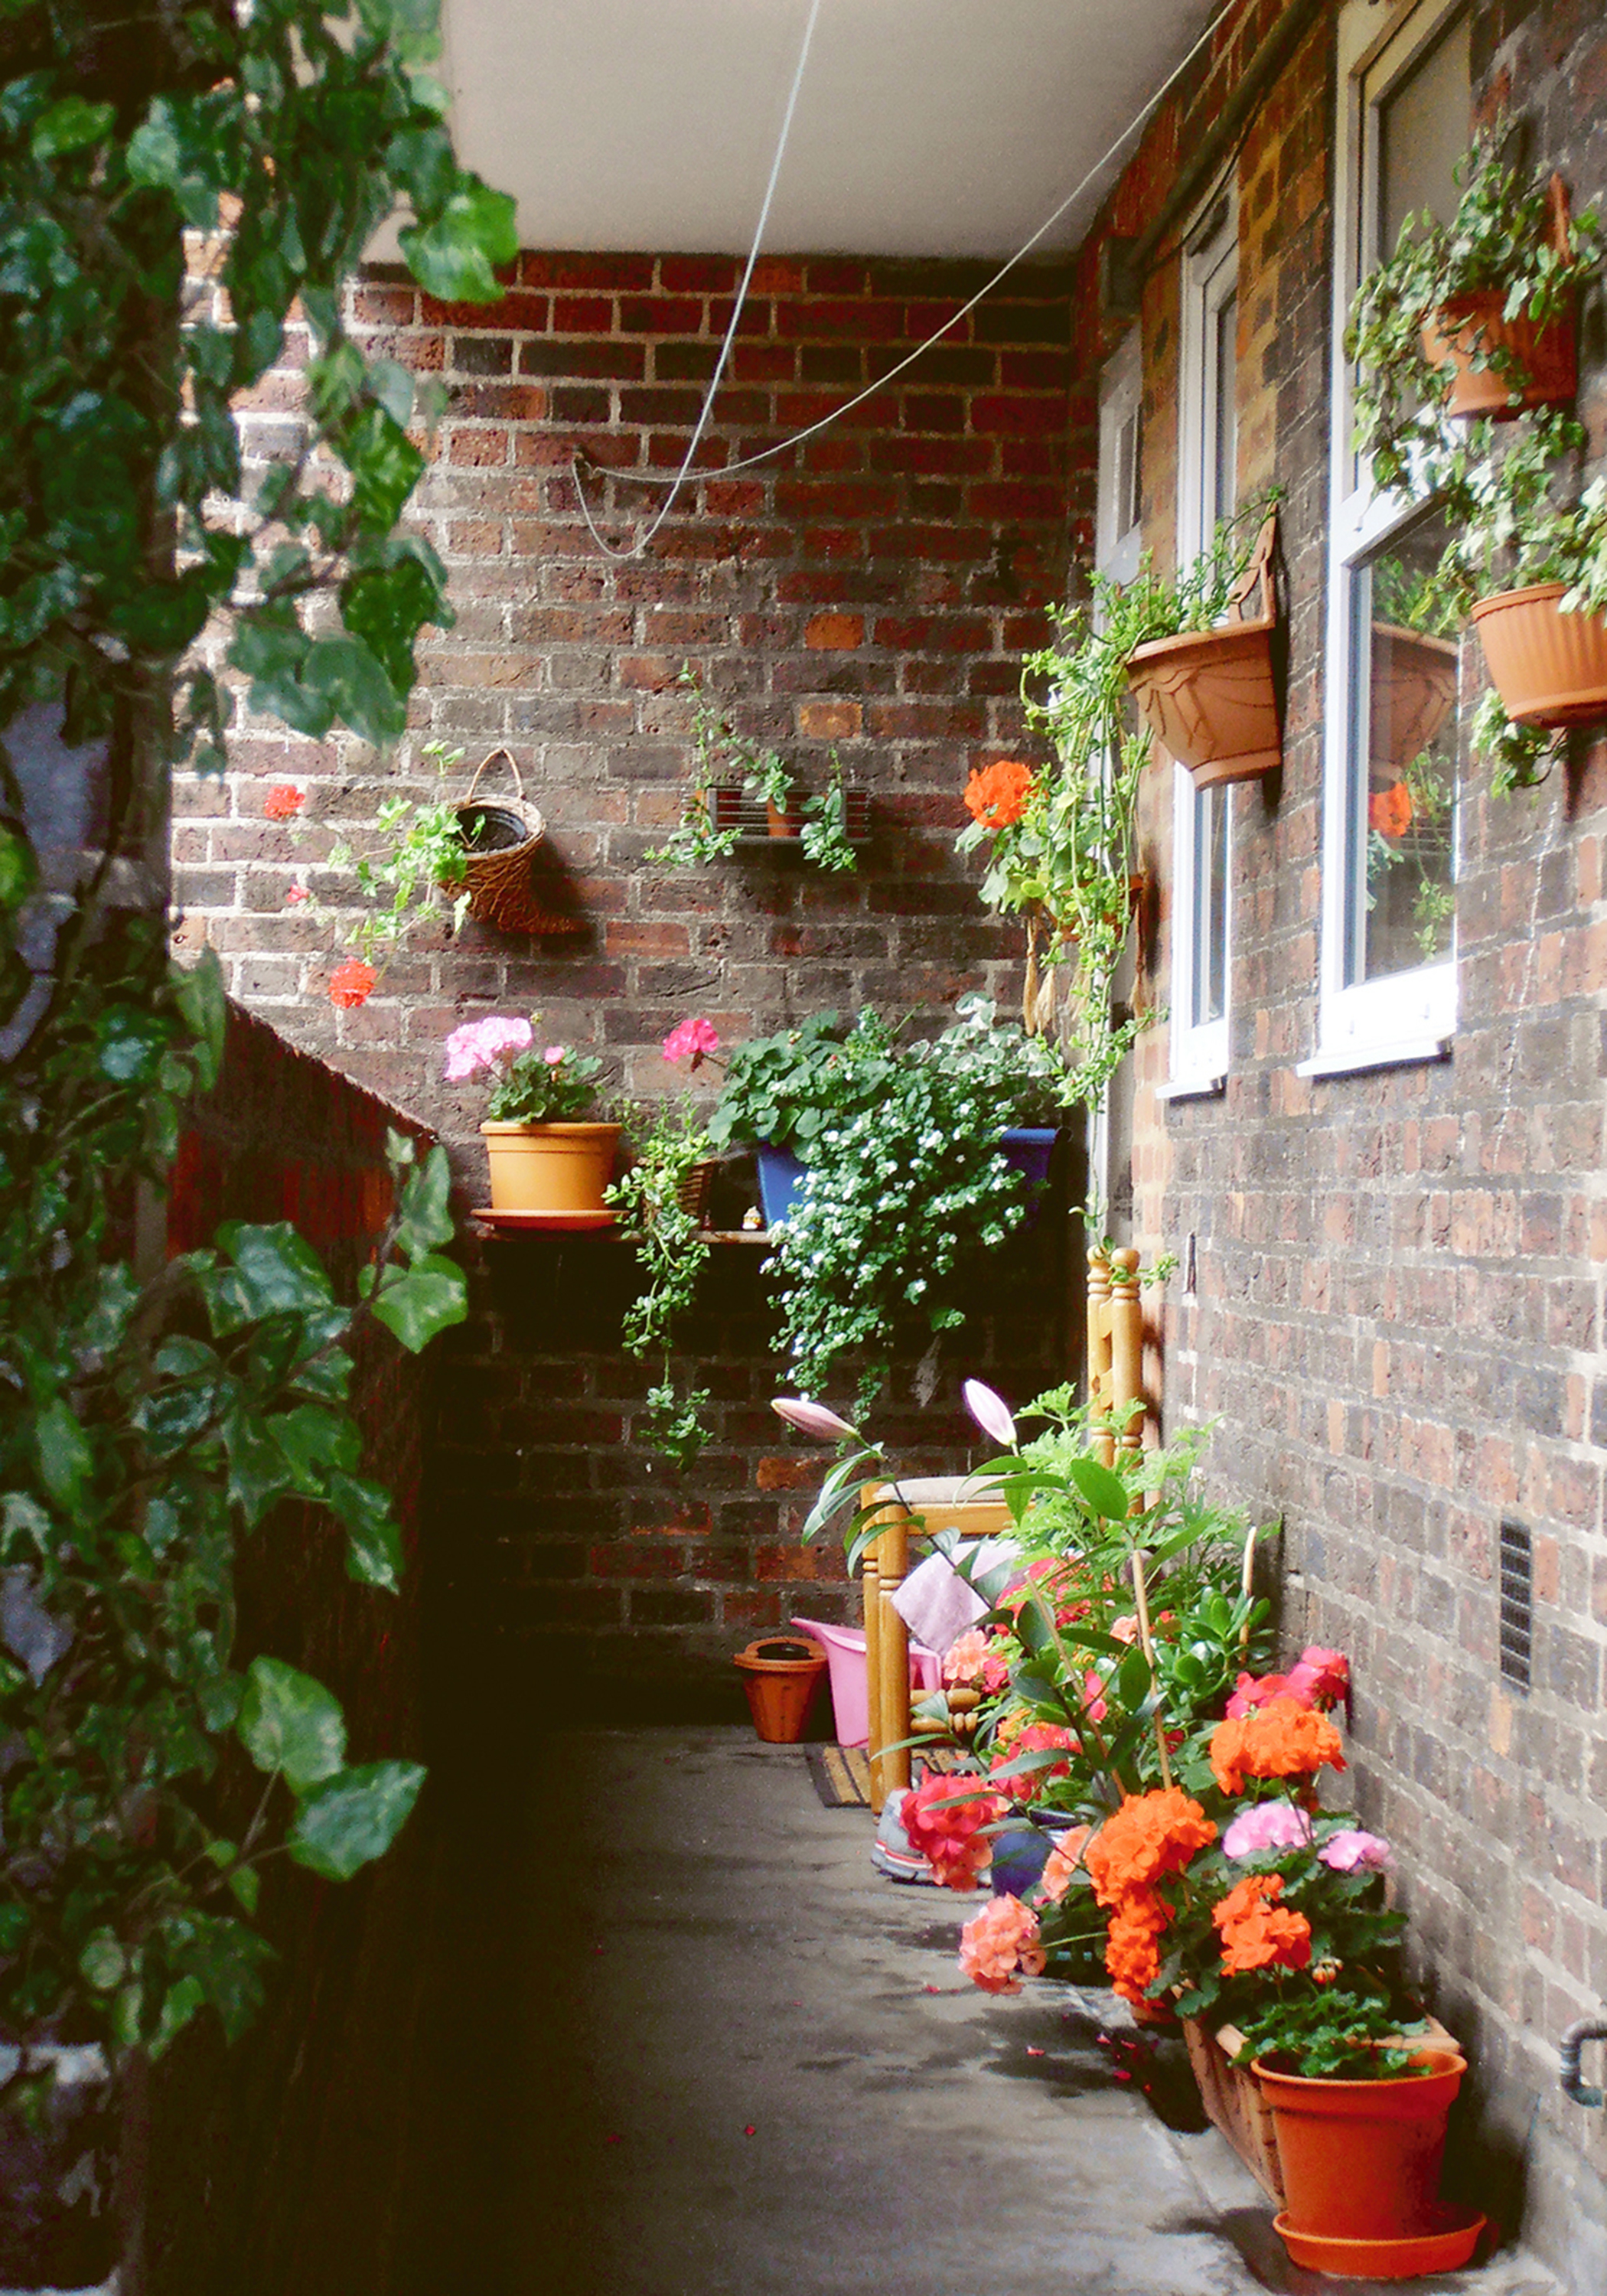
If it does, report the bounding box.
[1352,512,1458,980]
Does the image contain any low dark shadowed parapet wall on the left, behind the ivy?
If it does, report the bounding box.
[147,1008,432,2296]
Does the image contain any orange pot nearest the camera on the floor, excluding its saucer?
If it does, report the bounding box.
[1253,2048,1467,2241]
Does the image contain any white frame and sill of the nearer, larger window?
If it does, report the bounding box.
[1297,0,1467,1077]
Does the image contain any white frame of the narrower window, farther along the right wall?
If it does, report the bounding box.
[1166,184,1240,1100]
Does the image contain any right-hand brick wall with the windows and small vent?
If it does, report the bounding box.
[1074,0,1607,2296]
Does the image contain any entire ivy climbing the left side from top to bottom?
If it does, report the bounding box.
[0,0,517,2103]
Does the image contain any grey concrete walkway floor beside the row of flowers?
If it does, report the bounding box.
[395,1729,1554,2296]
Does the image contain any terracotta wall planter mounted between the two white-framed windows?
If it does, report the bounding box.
[1127,514,1283,790]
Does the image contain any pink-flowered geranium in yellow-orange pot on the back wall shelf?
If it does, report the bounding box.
[445,1015,620,1226]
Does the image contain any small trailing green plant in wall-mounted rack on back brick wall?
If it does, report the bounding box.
[647,661,859,875]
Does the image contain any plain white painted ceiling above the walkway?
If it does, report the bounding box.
[445,0,1221,257]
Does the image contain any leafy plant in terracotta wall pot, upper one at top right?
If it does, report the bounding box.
[1345,124,1600,461]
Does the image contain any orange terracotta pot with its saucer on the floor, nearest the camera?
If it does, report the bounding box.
[1253,2046,1485,2280]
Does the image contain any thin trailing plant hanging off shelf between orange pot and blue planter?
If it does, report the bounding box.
[604,1093,712,1467]
